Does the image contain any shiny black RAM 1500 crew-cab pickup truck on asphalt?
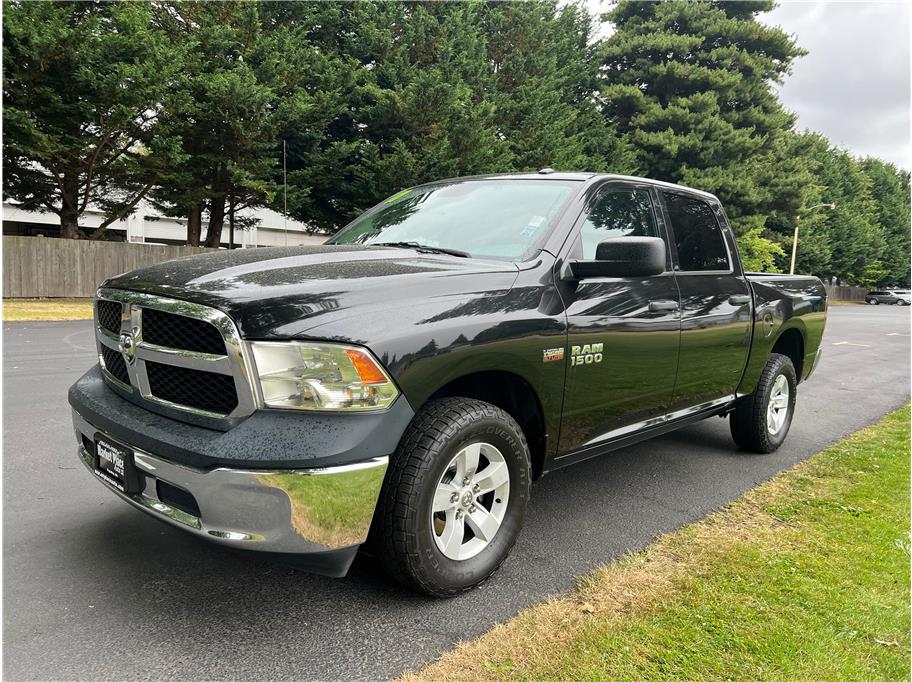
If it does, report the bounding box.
[69,170,826,596]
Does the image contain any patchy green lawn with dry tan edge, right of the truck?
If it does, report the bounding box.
[411,406,910,680]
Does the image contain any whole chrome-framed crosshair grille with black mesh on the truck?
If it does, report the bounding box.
[95,289,255,418]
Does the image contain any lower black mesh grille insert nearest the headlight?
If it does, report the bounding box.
[143,362,238,415]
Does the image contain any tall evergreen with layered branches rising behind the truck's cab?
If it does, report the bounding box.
[602,0,811,269]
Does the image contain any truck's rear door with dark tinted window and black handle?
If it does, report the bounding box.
[661,189,752,412]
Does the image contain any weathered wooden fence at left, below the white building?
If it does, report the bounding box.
[3,236,212,298]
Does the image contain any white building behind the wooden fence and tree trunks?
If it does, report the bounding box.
[3,201,327,248]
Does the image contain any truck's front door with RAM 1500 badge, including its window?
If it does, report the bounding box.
[559,183,680,453]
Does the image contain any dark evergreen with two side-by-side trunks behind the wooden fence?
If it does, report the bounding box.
[153,2,275,246]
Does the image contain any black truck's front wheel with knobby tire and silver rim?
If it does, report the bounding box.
[371,398,532,597]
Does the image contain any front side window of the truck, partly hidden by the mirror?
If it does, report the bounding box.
[580,187,658,260]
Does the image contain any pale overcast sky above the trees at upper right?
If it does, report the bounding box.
[587,0,912,169]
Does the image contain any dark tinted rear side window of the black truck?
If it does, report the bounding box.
[662,192,731,272]
